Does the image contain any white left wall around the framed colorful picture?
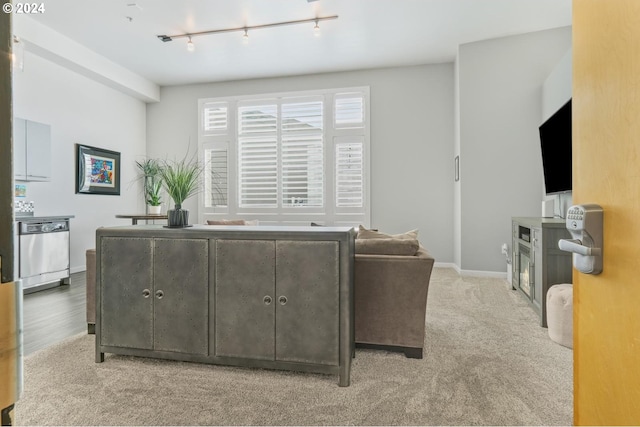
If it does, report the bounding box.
[13,52,146,272]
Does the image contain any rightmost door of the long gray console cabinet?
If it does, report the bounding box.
[275,241,340,365]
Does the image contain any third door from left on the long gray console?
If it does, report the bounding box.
[214,239,276,360]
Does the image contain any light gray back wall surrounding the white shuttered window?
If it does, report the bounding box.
[147,63,454,262]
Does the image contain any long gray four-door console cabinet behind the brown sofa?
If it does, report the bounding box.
[96,225,355,386]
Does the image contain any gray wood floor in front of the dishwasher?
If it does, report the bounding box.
[23,272,87,356]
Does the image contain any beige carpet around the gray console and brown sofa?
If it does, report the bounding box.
[16,269,573,425]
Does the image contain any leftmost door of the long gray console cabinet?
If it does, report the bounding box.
[99,237,153,350]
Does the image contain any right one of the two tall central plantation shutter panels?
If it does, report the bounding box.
[281,101,324,206]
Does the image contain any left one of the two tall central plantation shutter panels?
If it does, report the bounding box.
[238,105,278,207]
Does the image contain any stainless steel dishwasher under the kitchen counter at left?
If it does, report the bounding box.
[18,219,69,293]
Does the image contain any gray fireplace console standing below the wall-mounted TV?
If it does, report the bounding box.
[511,217,573,327]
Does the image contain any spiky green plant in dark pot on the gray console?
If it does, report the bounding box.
[160,156,202,227]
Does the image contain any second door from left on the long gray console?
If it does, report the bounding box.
[152,239,209,355]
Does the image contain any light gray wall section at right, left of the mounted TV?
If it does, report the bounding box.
[457,27,571,272]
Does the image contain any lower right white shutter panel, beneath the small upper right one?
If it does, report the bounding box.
[335,137,364,208]
